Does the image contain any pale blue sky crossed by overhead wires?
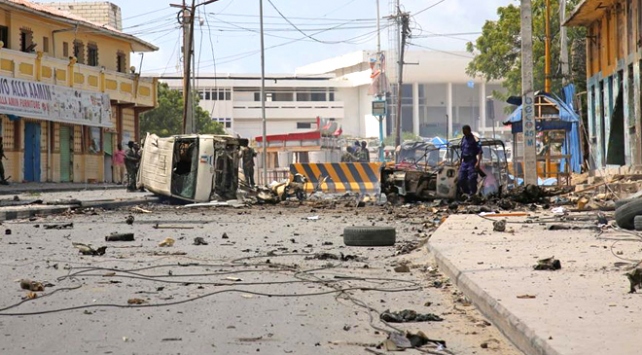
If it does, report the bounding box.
[65,0,519,75]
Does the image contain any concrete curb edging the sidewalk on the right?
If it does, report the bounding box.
[428,242,561,355]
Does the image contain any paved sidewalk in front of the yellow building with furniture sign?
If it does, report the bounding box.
[0,184,159,221]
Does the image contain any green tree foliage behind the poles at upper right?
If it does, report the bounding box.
[466,0,586,98]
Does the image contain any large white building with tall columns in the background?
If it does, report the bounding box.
[162,51,508,142]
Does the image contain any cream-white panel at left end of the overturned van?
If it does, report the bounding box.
[138,133,174,196]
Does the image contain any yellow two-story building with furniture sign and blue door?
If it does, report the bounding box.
[0,0,157,182]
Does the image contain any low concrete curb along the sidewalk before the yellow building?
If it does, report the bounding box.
[0,197,160,222]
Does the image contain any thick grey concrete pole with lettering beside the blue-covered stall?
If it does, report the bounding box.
[521,0,537,186]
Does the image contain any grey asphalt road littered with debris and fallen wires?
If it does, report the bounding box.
[0,205,520,355]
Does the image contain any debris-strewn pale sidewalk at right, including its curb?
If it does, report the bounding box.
[429,215,642,355]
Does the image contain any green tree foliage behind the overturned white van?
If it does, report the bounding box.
[140,83,225,137]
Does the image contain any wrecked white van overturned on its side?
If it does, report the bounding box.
[137,133,248,202]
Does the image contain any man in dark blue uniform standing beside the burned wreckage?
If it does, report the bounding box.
[457,125,482,195]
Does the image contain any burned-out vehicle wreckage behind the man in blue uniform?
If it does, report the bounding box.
[380,139,508,203]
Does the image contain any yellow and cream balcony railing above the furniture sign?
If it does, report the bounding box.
[0,48,156,107]
